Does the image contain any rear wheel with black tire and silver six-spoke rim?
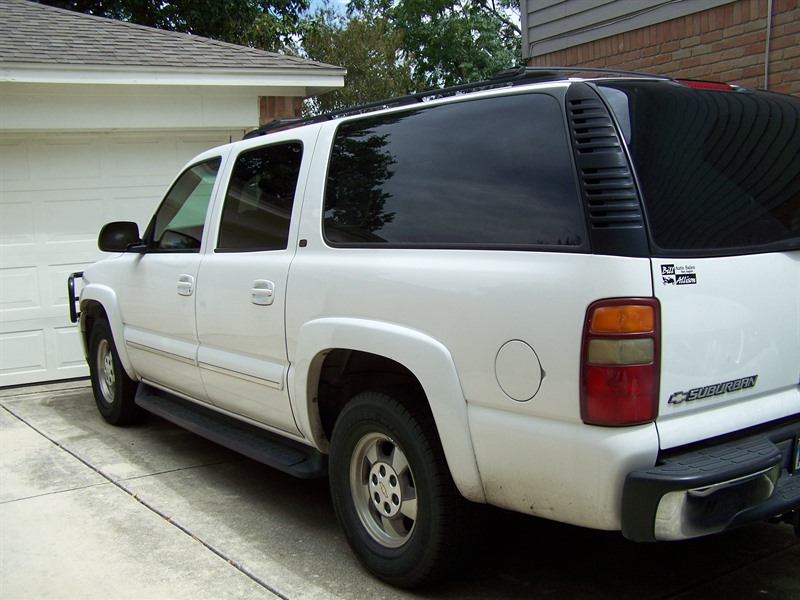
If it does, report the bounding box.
[329,390,468,588]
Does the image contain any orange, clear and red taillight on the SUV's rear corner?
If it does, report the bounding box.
[581,298,660,426]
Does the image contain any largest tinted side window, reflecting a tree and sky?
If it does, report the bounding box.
[324,94,586,250]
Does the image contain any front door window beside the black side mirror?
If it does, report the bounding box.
[148,158,221,252]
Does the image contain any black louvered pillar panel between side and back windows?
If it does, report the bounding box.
[566,83,647,256]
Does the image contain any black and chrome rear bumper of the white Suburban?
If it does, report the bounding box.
[622,418,800,542]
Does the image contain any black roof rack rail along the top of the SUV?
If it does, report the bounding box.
[244,66,671,139]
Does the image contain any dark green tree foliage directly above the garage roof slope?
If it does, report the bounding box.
[40,0,309,51]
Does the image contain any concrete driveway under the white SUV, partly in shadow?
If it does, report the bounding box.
[0,382,800,600]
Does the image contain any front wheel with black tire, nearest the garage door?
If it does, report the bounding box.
[89,319,147,425]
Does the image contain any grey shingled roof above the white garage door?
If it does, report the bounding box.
[0,0,344,74]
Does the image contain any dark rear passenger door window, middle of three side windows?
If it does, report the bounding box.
[217,142,303,252]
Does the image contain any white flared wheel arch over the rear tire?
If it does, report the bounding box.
[289,317,486,502]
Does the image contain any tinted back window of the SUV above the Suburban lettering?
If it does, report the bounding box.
[601,82,800,255]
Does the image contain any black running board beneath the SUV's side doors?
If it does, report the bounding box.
[136,383,328,479]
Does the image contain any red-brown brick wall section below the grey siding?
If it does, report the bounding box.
[528,0,800,95]
